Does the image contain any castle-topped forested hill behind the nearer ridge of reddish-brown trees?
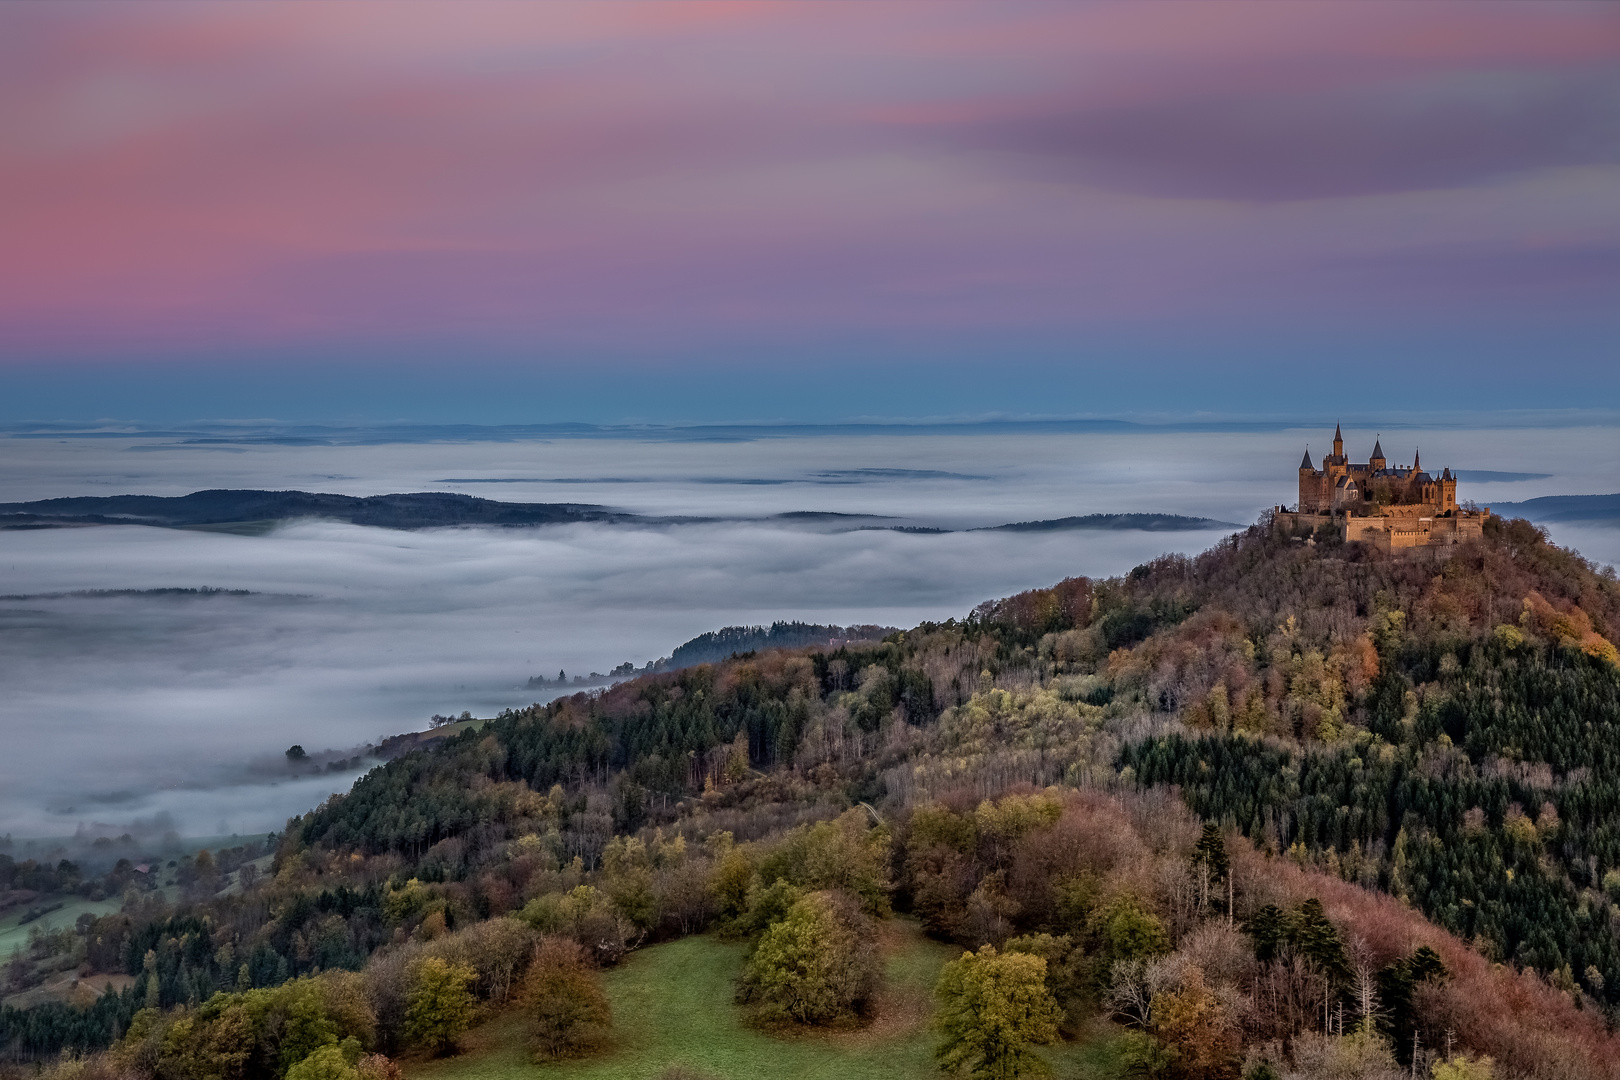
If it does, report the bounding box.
[300,508,1620,977]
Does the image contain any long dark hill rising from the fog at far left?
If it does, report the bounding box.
[0,491,635,529]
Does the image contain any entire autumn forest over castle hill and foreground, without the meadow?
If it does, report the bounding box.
[0,521,1620,1080]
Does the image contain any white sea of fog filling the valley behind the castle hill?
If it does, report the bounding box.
[0,427,1620,837]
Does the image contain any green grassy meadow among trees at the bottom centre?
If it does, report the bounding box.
[407,920,1121,1080]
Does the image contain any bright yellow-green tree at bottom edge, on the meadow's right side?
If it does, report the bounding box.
[935,946,1061,1080]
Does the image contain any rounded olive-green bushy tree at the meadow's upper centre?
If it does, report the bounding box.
[737,892,876,1023]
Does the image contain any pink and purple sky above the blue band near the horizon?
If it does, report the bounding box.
[0,0,1620,417]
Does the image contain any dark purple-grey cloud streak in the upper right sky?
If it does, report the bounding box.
[948,66,1620,202]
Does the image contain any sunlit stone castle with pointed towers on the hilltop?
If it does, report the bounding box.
[1277,426,1490,551]
